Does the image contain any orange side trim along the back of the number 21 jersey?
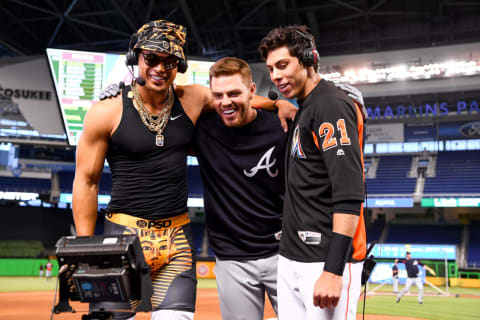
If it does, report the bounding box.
[352,102,367,260]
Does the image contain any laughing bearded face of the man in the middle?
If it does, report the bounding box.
[210,74,257,127]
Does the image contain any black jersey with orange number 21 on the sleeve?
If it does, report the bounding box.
[280,80,366,262]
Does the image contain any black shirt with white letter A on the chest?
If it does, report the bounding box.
[194,110,287,260]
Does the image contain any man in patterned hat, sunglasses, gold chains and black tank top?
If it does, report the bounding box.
[73,20,295,320]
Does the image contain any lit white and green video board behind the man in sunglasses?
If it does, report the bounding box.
[47,49,213,145]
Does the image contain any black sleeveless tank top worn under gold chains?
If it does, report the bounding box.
[107,87,194,219]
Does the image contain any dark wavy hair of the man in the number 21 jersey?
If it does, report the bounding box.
[258,25,318,72]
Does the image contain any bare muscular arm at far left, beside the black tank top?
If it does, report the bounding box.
[73,98,117,236]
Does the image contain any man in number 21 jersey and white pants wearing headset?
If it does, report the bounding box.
[259,26,366,320]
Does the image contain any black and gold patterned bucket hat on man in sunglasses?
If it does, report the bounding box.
[133,20,187,60]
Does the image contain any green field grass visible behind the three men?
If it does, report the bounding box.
[0,277,480,320]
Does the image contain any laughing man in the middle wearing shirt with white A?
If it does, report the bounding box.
[194,58,287,320]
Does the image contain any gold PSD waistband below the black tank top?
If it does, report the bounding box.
[105,212,190,230]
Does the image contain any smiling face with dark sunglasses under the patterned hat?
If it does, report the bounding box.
[138,50,178,91]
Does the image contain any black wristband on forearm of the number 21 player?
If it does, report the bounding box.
[324,232,353,276]
